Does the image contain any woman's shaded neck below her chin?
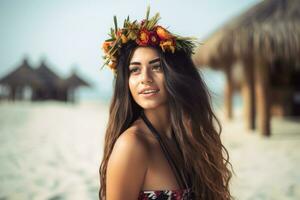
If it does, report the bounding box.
[144,105,172,139]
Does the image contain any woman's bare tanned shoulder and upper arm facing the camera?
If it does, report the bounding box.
[106,126,150,199]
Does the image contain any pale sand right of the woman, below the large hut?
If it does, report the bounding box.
[219,108,300,200]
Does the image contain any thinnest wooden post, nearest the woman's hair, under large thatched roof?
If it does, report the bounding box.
[224,65,233,120]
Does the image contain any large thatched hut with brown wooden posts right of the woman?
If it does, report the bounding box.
[194,0,300,135]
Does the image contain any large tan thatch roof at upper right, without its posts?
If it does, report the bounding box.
[193,0,300,68]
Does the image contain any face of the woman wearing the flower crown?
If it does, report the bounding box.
[129,47,167,109]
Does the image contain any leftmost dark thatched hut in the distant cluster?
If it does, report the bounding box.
[0,58,44,100]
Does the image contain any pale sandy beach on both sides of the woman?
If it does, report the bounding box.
[0,102,300,200]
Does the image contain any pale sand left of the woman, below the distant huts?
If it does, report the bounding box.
[0,102,108,200]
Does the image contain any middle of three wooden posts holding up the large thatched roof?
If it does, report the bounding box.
[241,60,255,130]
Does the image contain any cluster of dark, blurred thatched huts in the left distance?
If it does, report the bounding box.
[0,58,90,102]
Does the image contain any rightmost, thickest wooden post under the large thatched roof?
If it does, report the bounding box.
[255,58,271,136]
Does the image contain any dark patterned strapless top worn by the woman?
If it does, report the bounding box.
[138,188,192,200]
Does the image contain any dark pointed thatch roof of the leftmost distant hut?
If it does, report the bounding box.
[0,58,44,87]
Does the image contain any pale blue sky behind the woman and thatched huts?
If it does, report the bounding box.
[0,0,259,99]
